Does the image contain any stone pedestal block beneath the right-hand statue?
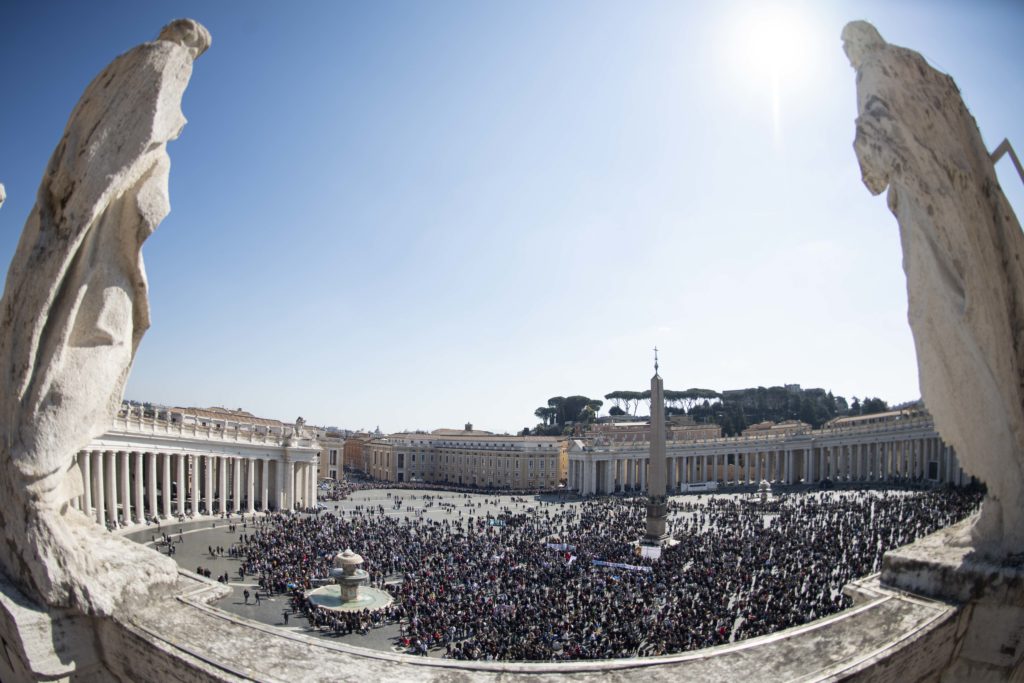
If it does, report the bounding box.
[882,517,1024,683]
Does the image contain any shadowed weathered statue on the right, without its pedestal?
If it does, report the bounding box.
[843,22,1024,557]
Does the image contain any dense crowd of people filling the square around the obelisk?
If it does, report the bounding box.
[240,489,981,660]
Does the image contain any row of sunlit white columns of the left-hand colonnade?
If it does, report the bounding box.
[71,451,316,528]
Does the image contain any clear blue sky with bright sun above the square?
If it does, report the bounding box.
[0,1,1024,431]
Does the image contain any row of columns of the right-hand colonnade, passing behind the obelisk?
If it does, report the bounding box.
[568,433,970,495]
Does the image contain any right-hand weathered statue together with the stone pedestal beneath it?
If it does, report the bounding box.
[843,22,1024,681]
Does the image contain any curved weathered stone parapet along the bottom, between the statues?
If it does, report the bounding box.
[41,571,957,683]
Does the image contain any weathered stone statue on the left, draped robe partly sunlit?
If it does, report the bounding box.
[0,19,210,614]
